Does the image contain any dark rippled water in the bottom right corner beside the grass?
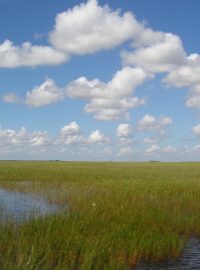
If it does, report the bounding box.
[136,238,200,270]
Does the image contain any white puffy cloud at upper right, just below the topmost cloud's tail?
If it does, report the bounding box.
[121,33,185,73]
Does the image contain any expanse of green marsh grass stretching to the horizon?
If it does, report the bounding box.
[0,161,200,270]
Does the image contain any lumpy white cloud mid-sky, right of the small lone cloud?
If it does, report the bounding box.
[65,67,150,120]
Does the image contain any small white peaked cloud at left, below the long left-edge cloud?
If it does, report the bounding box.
[26,79,64,107]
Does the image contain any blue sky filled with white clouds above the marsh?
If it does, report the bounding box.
[0,0,200,161]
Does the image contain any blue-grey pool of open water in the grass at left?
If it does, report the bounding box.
[0,188,60,223]
